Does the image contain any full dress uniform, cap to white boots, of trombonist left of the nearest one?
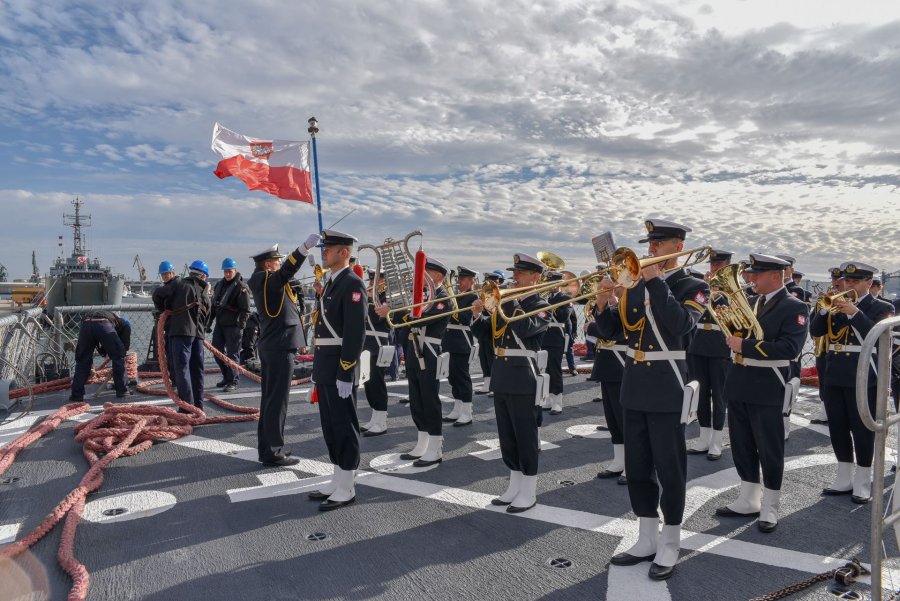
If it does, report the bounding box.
[472,253,550,513]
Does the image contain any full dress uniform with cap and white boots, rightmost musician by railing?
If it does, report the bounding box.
[810,261,894,504]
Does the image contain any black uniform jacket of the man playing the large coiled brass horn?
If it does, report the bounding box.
[725,288,809,407]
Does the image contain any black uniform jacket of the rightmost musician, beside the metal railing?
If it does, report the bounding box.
[809,294,894,387]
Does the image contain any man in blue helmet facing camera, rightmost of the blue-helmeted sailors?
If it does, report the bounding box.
[210,258,250,392]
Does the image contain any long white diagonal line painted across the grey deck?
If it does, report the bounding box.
[170,435,900,584]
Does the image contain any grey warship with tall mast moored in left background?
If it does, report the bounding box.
[46,197,125,313]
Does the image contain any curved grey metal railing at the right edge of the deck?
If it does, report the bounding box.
[856,317,900,599]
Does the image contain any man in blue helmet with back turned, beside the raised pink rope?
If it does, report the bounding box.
[153,260,210,409]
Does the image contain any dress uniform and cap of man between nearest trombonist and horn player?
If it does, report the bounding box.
[687,250,733,461]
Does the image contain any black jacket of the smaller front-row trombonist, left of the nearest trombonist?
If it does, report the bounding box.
[472,294,550,395]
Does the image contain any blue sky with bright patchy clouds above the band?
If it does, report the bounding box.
[0,0,900,284]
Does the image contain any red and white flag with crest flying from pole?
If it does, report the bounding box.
[212,123,313,203]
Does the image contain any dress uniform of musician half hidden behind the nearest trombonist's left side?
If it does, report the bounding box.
[591,296,628,484]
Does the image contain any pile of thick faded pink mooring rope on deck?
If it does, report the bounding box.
[0,311,309,601]
